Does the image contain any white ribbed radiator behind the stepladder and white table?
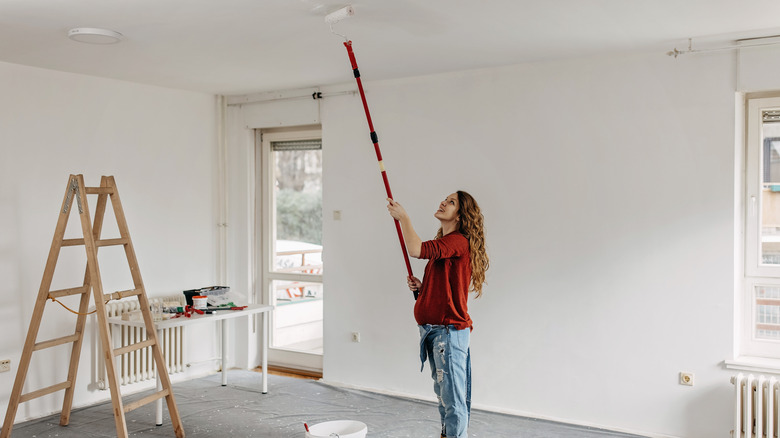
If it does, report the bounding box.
[98,295,185,389]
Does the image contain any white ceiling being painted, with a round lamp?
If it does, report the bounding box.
[0,0,780,95]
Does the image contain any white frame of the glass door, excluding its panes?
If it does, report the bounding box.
[255,126,322,372]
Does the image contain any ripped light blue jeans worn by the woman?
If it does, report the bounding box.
[419,324,471,438]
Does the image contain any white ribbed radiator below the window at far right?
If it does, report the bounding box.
[731,373,780,438]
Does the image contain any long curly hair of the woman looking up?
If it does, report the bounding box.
[436,190,490,298]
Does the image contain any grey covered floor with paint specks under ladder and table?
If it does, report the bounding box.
[12,370,640,438]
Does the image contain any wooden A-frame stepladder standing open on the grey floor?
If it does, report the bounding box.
[0,175,184,438]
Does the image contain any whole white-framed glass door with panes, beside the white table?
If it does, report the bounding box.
[258,129,324,370]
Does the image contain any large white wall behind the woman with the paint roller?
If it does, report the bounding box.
[225,45,780,438]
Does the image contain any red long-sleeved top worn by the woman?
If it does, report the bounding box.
[414,231,471,330]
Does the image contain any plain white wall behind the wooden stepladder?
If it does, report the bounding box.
[0,63,217,421]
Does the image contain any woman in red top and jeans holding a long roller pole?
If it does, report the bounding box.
[387,191,489,438]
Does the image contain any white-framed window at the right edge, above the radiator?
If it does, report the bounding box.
[739,96,780,359]
